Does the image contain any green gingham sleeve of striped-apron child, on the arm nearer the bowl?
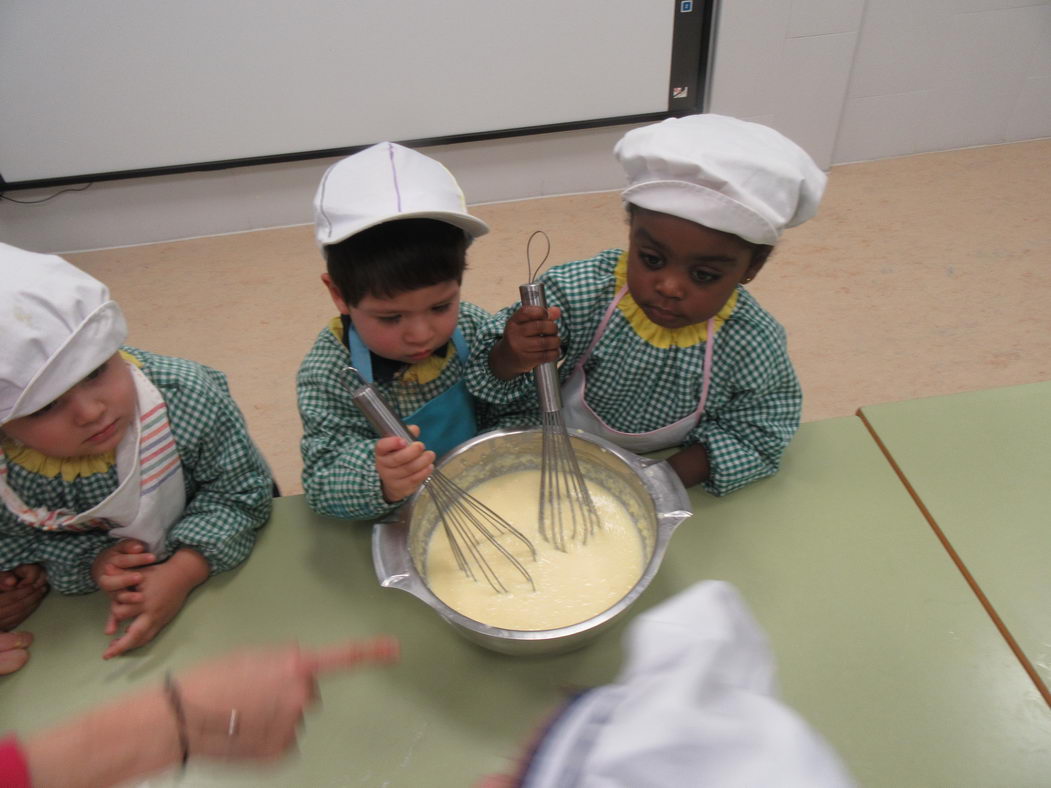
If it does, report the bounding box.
[166,373,273,575]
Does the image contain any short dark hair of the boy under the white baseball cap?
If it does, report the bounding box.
[324,219,472,307]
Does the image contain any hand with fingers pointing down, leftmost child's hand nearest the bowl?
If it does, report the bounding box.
[102,547,209,660]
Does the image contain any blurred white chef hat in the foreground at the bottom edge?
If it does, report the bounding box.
[522,581,854,788]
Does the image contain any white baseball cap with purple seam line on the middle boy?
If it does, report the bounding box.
[314,142,489,246]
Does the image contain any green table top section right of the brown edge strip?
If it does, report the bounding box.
[862,381,1051,702]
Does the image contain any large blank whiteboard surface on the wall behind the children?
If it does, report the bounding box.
[0,0,695,187]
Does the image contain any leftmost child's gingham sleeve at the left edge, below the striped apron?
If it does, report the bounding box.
[0,521,114,594]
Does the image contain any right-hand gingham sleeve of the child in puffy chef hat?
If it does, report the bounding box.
[685,335,803,495]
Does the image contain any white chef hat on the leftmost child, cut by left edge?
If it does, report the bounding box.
[0,244,127,424]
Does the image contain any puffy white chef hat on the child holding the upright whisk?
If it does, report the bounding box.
[614,113,827,245]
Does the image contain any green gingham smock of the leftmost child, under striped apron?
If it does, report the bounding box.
[0,348,273,594]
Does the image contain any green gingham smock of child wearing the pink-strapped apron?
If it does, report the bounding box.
[465,249,802,495]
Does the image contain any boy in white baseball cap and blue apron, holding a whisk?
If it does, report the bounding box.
[296,142,538,519]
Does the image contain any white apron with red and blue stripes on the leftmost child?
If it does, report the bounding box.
[0,364,186,557]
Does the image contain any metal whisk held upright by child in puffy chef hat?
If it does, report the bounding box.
[518,230,602,553]
